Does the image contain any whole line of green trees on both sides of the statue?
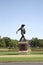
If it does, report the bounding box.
[0,37,43,48]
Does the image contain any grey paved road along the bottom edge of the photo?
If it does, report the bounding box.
[0,62,43,65]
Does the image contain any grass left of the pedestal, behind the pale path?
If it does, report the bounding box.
[0,49,19,55]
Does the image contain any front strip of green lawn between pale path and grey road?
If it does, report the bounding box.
[0,57,43,62]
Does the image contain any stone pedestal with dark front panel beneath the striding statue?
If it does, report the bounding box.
[19,41,28,54]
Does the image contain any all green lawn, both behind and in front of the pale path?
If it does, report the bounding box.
[0,49,43,62]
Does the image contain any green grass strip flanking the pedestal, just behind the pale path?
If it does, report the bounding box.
[0,50,43,55]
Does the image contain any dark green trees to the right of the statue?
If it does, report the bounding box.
[29,38,43,48]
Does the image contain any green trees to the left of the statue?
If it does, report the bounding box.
[0,37,18,48]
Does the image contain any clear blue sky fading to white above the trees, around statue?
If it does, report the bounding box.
[0,0,43,40]
